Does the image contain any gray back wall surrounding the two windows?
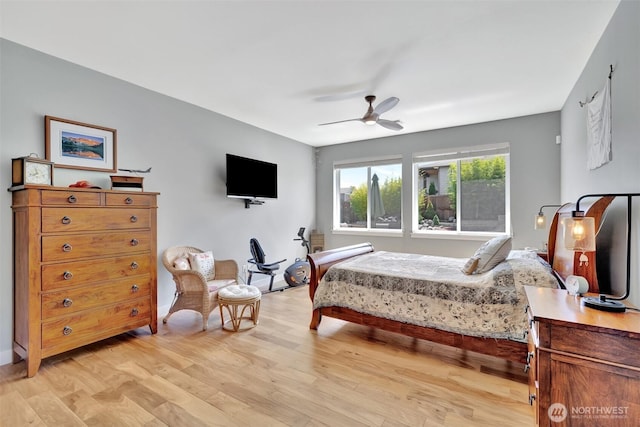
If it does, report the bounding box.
[316,112,560,257]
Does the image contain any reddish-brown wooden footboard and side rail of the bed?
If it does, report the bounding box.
[308,243,527,363]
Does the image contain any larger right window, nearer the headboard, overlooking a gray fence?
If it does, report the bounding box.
[413,144,511,234]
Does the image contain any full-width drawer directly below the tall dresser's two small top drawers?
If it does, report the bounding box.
[42,208,151,233]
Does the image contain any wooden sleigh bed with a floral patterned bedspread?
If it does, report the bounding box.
[308,198,611,363]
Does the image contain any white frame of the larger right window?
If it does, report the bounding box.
[411,142,511,241]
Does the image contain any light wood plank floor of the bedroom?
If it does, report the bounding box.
[0,287,534,427]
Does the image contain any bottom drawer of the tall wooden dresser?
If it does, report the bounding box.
[42,298,151,357]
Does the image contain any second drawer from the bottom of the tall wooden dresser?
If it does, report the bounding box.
[42,274,151,320]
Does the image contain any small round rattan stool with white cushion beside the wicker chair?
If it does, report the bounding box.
[218,285,262,332]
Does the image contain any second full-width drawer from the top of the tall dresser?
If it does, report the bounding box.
[42,230,152,262]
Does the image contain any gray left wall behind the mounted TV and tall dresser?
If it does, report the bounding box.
[0,39,315,365]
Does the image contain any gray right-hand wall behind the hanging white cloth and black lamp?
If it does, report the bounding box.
[561,0,640,305]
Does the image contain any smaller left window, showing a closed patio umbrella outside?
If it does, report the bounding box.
[333,157,402,230]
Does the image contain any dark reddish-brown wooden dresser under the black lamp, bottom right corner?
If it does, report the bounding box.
[525,286,640,427]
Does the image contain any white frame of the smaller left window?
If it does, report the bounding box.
[332,155,405,237]
